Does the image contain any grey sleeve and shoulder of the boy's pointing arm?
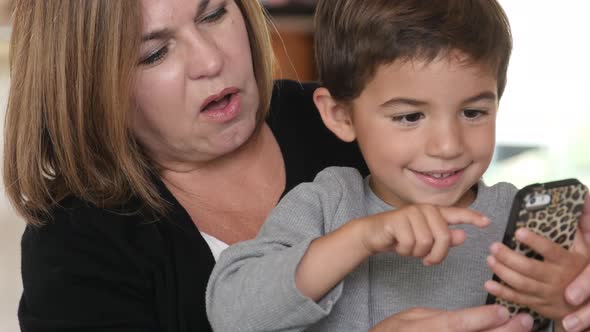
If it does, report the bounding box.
[206,169,363,331]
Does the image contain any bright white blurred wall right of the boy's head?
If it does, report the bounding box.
[486,0,590,186]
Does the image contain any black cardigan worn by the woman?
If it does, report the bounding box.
[18,81,367,332]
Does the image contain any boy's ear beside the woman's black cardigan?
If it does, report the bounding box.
[313,88,356,142]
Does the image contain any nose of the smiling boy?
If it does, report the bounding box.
[426,123,464,159]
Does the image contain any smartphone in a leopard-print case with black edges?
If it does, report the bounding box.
[486,179,588,331]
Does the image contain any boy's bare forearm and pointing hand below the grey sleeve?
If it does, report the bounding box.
[295,205,489,301]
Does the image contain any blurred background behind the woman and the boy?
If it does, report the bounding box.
[0,0,590,331]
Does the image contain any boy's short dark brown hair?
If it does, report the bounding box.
[315,0,512,102]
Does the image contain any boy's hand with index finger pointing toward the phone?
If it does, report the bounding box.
[362,205,490,265]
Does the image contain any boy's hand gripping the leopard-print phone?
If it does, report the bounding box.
[485,229,590,321]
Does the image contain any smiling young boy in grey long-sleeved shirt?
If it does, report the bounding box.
[207,0,587,331]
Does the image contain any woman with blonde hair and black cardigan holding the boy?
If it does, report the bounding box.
[4,0,590,331]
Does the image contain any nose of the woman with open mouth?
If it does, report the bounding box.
[186,31,223,79]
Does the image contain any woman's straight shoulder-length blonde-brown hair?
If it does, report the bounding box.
[3,0,273,225]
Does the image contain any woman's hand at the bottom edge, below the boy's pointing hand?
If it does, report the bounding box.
[370,305,533,332]
